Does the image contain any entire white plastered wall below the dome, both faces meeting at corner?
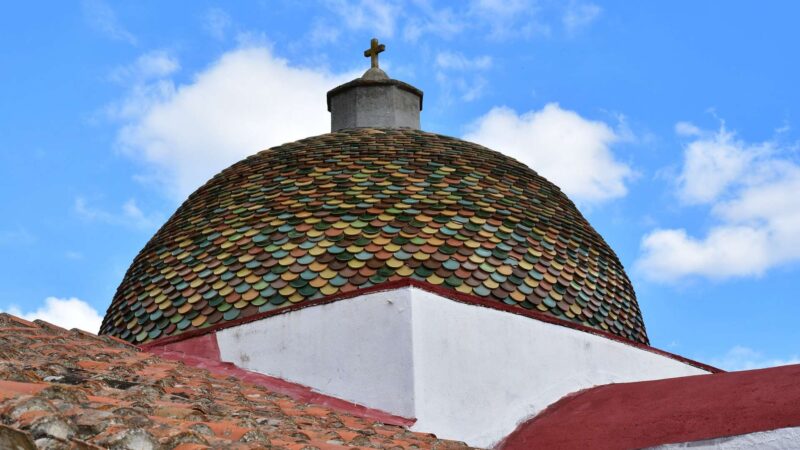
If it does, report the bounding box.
[217,288,706,447]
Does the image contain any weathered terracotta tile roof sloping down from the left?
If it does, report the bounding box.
[0,314,476,450]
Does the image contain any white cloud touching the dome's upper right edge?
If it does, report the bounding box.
[465,103,633,204]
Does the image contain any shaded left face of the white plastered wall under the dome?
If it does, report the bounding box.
[217,289,415,417]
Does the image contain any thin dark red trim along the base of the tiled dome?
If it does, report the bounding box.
[139,278,722,373]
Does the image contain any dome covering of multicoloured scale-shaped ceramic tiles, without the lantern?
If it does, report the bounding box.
[101,128,648,344]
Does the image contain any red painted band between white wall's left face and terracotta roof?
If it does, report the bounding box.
[146,333,416,427]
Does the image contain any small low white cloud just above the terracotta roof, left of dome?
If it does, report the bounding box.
[7,297,103,333]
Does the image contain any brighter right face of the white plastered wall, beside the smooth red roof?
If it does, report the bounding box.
[412,289,706,446]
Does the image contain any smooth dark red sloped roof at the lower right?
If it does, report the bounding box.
[499,365,800,450]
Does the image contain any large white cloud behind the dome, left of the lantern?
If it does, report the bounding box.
[110,46,356,199]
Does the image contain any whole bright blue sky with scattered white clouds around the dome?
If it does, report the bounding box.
[0,0,800,369]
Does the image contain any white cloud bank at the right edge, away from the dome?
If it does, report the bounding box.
[636,121,800,282]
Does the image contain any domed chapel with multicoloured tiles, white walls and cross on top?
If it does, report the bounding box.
[76,39,800,448]
